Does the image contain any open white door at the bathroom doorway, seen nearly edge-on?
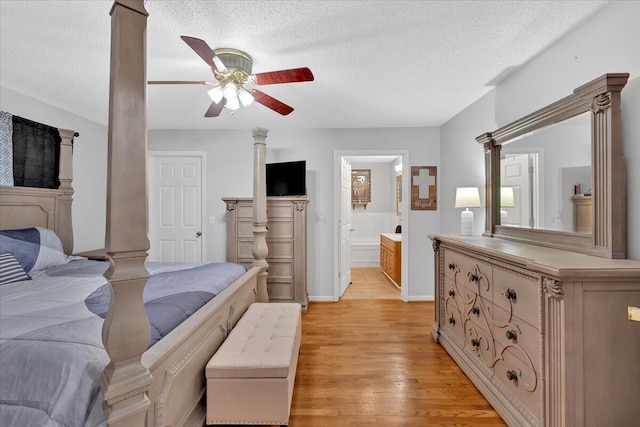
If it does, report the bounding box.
[338,157,351,296]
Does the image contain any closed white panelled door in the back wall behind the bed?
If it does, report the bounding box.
[148,153,203,262]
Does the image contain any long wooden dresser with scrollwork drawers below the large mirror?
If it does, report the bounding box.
[430,236,640,427]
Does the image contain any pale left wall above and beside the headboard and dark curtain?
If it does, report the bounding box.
[0,88,107,252]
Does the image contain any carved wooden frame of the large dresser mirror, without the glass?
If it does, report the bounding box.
[476,73,629,258]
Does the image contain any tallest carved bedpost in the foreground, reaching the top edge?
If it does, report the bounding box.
[100,0,151,427]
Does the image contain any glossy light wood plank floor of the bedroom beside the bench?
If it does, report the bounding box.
[282,298,506,427]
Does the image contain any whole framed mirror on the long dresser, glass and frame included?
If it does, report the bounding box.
[476,73,629,258]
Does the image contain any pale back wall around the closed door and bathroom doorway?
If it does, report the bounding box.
[149,128,440,301]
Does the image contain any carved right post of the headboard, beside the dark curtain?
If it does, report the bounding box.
[56,129,78,254]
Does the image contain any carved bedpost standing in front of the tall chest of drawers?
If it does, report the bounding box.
[252,128,269,302]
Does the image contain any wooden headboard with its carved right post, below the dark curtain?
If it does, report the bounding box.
[0,129,77,254]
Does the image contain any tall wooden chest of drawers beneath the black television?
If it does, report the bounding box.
[222,197,309,313]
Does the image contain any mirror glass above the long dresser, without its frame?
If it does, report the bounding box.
[500,112,592,234]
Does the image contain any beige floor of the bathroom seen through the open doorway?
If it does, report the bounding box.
[341,267,400,299]
